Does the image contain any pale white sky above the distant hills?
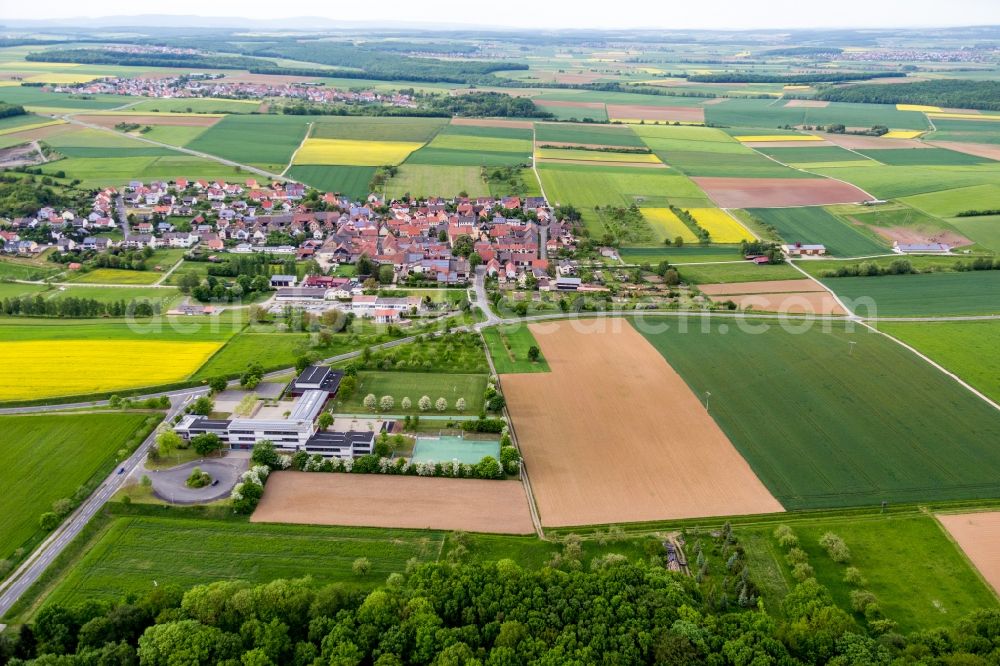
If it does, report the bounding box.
[0,0,1000,29]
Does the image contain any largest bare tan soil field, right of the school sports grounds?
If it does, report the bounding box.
[502,318,783,527]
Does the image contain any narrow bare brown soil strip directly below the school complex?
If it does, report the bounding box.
[250,472,534,534]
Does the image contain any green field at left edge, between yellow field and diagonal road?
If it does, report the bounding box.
[0,414,147,560]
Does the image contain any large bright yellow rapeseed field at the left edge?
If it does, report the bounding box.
[0,340,222,400]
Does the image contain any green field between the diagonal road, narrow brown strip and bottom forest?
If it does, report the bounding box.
[41,517,445,603]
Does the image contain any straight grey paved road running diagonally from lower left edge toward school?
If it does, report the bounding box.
[0,396,197,617]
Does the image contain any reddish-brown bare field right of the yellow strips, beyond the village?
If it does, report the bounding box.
[691,177,872,208]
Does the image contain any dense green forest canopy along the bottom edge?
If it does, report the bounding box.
[0,552,1000,666]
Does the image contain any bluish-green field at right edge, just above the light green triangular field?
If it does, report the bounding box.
[823,271,1000,317]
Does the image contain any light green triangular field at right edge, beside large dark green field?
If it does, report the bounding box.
[878,321,1000,402]
